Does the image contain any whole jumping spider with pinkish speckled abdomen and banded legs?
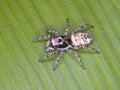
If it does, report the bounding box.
[33,18,98,71]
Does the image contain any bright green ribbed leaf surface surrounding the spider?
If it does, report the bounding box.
[0,0,120,90]
